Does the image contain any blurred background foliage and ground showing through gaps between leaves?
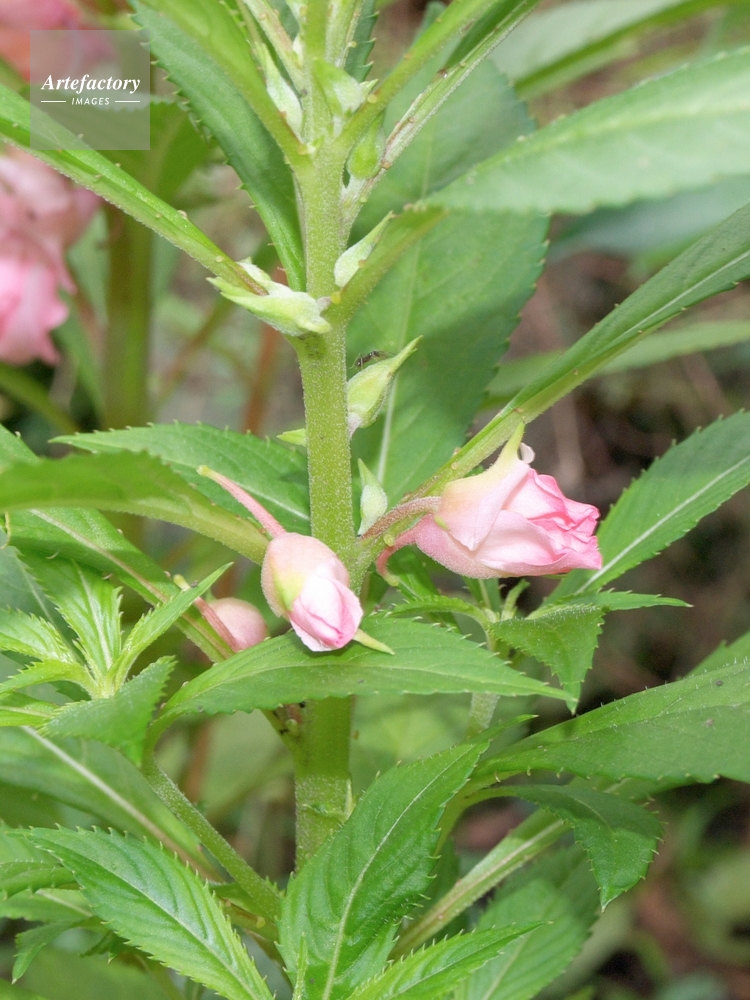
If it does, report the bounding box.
[0,0,750,1000]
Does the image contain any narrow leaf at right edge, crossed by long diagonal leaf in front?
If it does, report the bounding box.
[484,322,750,408]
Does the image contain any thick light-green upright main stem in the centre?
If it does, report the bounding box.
[295,137,356,866]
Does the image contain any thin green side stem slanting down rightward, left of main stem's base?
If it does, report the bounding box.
[142,748,280,924]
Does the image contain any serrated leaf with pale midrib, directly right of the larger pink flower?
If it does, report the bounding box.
[555,413,750,596]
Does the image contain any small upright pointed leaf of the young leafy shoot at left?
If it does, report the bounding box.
[26,557,121,677]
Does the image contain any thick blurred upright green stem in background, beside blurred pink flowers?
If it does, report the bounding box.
[103,206,153,427]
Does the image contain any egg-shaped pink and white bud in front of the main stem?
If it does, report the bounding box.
[261,532,363,653]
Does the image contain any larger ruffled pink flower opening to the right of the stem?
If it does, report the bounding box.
[378,430,601,579]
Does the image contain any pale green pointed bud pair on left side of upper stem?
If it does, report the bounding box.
[208,259,331,337]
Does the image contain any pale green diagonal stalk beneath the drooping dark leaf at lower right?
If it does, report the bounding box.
[391,809,566,958]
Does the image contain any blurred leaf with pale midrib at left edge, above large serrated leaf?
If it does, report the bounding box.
[0,729,199,860]
